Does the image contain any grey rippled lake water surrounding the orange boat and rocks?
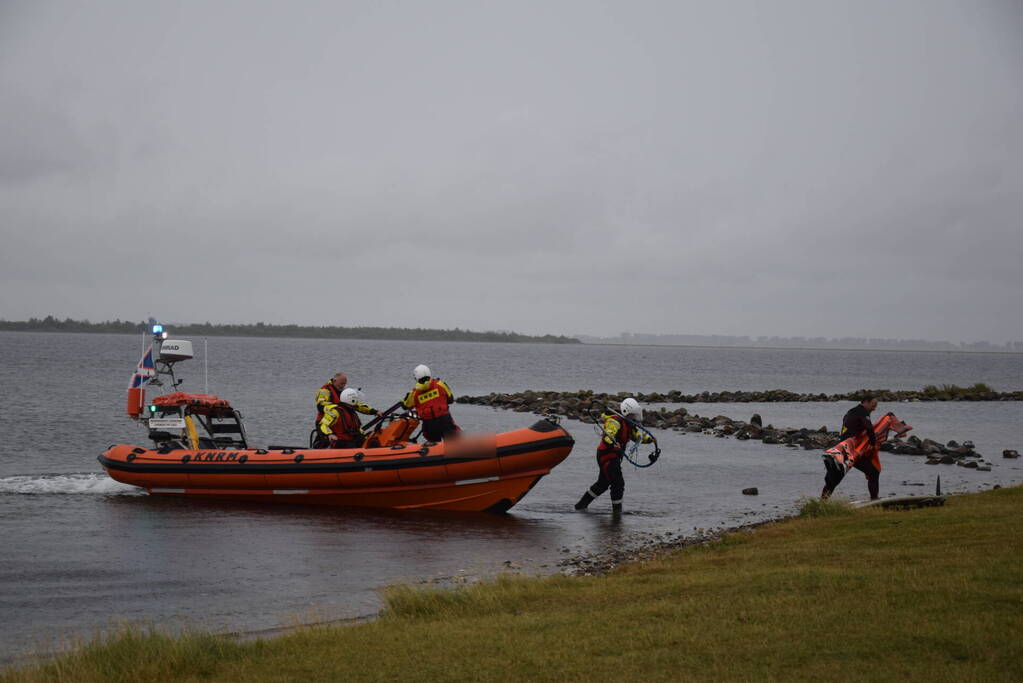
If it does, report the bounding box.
[0,332,1023,659]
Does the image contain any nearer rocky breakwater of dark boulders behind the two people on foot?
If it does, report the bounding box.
[458,391,998,471]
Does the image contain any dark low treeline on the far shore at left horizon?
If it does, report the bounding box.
[0,316,581,344]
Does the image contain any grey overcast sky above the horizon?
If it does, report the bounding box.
[0,0,1023,342]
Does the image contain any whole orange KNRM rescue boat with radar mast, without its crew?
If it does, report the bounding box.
[99,331,574,512]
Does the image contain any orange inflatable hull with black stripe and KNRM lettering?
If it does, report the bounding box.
[99,420,574,512]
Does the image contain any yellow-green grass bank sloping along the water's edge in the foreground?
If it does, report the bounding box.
[0,489,1023,682]
